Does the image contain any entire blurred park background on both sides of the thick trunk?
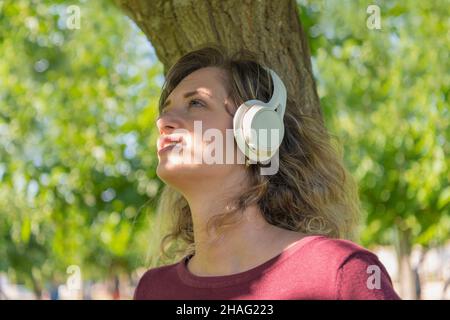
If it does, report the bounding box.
[0,0,450,299]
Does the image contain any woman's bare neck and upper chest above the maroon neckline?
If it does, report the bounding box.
[179,171,302,276]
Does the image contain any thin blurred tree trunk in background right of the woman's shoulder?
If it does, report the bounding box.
[396,227,418,300]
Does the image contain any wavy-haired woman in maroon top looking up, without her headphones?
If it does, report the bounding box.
[134,46,399,299]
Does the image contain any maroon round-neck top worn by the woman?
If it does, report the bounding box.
[134,235,400,300]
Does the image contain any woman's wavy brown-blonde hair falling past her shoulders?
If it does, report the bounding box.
[151,45,360,266]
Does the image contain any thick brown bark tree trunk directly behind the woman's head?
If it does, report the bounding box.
[115,0,323,123]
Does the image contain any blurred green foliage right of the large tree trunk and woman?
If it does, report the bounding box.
[298,0,450,246]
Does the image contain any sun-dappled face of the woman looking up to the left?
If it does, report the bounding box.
[156,67,244,189]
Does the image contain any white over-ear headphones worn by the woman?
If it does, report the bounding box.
[233,67,287,162]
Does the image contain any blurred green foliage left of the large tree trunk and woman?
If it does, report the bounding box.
[0,0,162,296]
